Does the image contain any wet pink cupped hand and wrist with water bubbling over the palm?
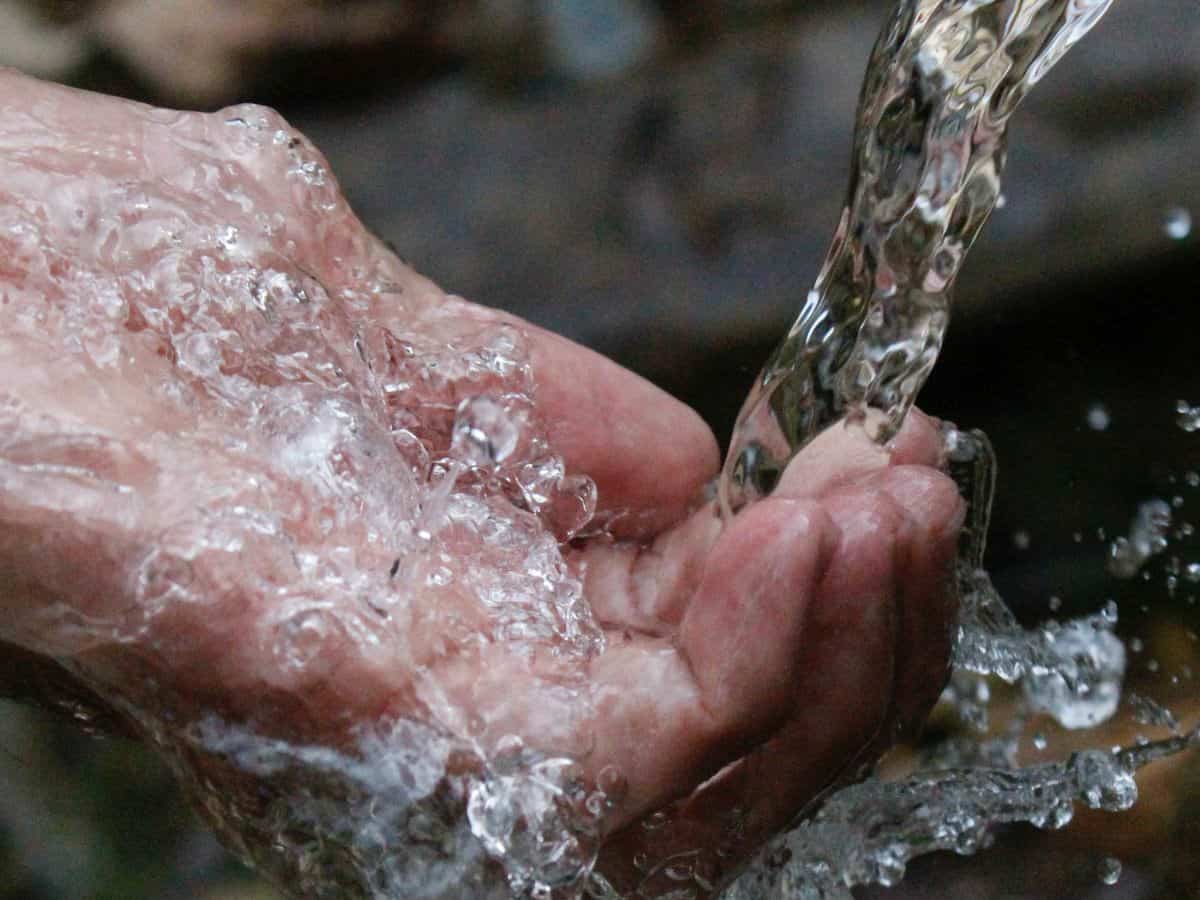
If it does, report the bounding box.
[0,72,961,896]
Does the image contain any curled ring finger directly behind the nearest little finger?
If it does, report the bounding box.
[597,492,902,893]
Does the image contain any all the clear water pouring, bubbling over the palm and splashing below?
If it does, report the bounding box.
[0,0,1200,900]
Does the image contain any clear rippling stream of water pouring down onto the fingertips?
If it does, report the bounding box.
[720,0,1111,510]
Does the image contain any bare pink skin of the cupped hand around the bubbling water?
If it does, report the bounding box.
[0,71,962,888]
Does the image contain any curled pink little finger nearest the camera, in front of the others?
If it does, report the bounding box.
[583,499,830,822]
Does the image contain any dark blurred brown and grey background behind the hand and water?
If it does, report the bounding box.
[0,0,1200,900]
